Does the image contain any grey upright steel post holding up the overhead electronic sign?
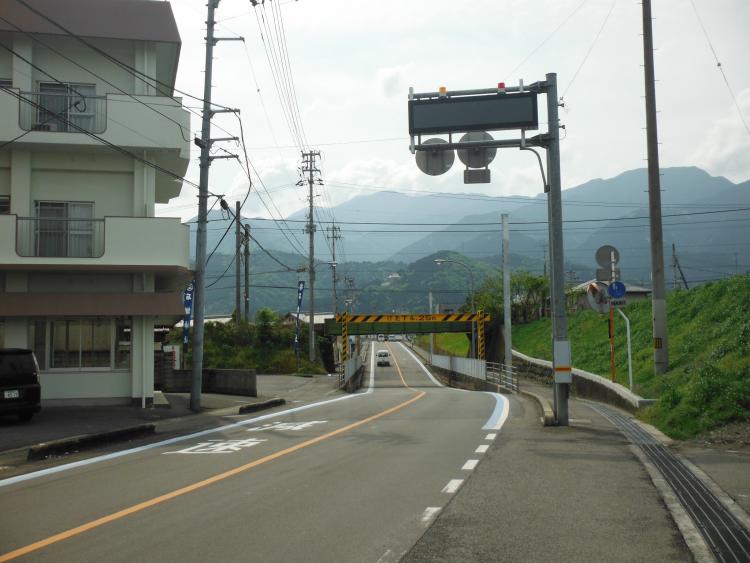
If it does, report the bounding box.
[546,72,572,426]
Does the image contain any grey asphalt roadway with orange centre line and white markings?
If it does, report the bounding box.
[0,343,509,561]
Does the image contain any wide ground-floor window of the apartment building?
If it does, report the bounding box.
[29,318,130,370]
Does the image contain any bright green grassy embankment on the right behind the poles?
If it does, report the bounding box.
[513,276,750,438]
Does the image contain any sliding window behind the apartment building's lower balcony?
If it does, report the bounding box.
[35,201,94,257]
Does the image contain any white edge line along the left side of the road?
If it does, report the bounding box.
[0,371,373,488]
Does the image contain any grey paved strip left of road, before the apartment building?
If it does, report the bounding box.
[0,375,337,479]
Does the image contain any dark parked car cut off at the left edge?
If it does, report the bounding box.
[0,348,42,421]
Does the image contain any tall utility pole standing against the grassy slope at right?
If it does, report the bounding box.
[642,0,669,374]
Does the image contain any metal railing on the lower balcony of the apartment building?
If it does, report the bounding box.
[16,217,104,258]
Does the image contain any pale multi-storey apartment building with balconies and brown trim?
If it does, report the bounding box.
[0,0,192,406]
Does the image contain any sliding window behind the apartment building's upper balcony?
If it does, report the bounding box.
[36,82,99,132]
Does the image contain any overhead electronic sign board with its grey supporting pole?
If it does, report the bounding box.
[409,73,572,426]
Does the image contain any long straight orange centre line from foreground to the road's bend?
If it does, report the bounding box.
[0,388,425,563]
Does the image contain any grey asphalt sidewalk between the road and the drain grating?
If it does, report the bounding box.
[402,380,750,563]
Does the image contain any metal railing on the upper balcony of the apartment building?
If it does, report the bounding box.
[18,92,107,133]
